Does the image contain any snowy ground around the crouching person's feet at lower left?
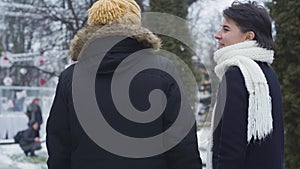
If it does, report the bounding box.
[0,143,48,169]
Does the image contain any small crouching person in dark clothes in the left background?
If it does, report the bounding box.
[19,121,42,156]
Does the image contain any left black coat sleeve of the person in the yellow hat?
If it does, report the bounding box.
[46,76,71,169]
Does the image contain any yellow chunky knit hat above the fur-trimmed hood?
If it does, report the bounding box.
[88,0,141,26]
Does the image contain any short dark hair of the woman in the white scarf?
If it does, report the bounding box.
[223,1,274,50]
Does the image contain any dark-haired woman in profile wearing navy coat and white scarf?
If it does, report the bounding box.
[212,2,284,169]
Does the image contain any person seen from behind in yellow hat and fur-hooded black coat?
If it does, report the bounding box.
[46,0,202,169]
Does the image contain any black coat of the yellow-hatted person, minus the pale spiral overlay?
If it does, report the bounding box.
[46,24,202,169]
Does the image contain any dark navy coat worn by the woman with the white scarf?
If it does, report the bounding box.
[213,62,284,169]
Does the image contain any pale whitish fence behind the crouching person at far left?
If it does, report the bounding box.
[0,86,55,139]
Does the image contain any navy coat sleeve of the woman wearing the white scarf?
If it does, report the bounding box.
[214,67,248,169]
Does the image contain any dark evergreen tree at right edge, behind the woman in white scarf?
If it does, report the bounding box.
[267,0,300,169]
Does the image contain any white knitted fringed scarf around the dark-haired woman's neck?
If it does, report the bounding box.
[207,41,274,167]
